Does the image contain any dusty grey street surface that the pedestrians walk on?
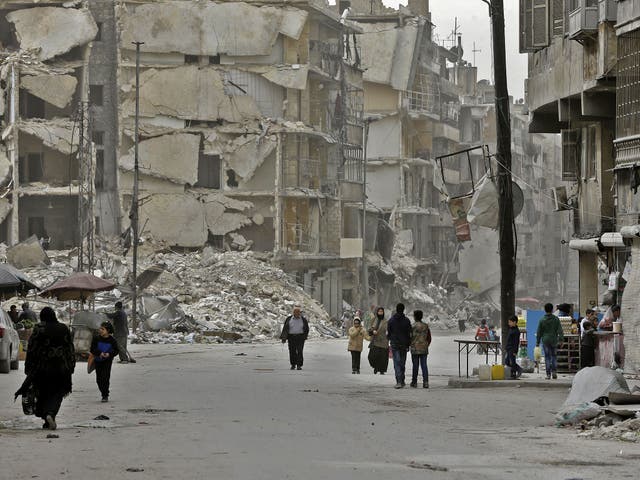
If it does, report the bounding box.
[0,334,640,480]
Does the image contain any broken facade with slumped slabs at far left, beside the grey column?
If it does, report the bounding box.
[0,0,98,248]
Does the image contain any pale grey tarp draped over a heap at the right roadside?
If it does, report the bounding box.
[564,367,630,406]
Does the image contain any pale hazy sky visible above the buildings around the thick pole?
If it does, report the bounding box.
[382,0,527,99]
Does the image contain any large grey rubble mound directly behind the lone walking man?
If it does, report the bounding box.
[138,247,338,340]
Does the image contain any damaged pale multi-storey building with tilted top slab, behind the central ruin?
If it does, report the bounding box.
[348,0,459,304]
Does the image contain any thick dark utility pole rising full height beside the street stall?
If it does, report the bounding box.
[485,0,516,348]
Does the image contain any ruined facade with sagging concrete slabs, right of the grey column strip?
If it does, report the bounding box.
[109,1,363,316]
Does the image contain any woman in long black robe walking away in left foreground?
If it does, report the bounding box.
[24,307,76,430]
